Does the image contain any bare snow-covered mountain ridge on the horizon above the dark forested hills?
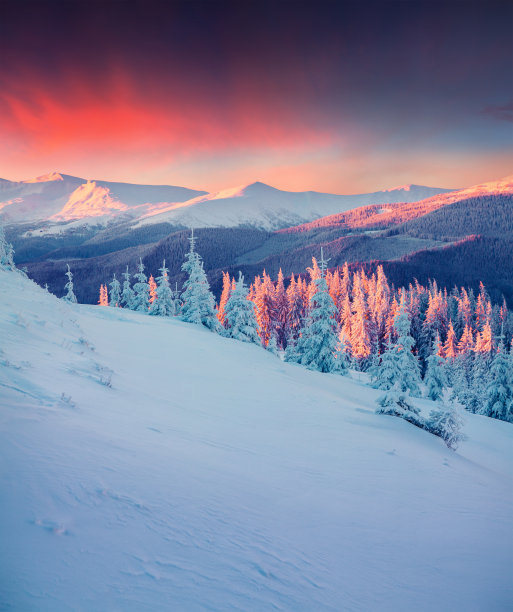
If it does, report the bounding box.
[0,172,448,234]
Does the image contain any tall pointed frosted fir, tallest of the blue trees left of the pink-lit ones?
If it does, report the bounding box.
[180,230,220,331]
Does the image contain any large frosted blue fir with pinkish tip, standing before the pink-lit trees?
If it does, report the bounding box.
[285,249,346,372]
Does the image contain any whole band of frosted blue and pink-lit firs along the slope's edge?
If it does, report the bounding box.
[62,227,513,432]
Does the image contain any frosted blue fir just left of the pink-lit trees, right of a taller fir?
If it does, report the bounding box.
[224,272,260,344]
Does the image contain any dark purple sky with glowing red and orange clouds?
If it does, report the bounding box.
[0,0,513,193]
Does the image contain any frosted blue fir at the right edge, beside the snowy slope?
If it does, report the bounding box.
[480,335,513,421]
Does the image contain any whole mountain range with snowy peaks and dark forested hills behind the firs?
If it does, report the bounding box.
[0,173,513,306]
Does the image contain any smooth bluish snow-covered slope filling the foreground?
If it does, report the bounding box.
[0,271,513,612]
